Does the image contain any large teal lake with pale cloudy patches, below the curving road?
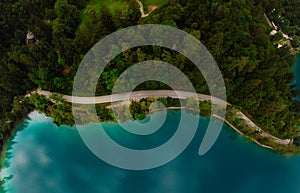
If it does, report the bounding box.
[1,111,300,193]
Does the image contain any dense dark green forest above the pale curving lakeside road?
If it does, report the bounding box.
[0,0,300,154]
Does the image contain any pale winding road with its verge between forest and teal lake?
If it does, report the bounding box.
[29,89,298,154]
